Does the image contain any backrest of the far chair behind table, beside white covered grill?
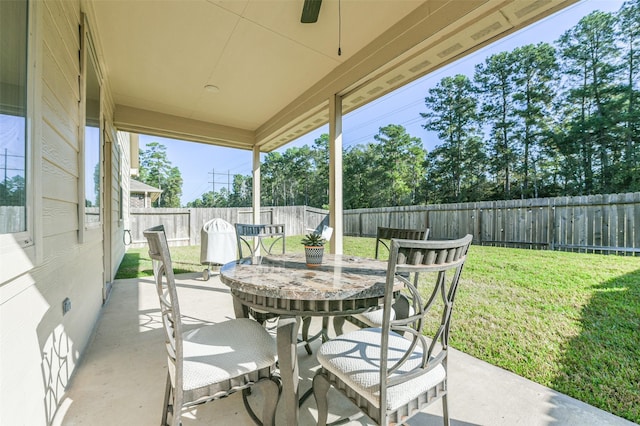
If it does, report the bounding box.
[235,223,285,258]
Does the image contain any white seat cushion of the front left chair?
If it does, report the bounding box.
[183,318,277,400]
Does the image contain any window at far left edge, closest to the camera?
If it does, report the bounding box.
[0,0,30,235]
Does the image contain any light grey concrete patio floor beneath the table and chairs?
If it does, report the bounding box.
[53,273,635,426]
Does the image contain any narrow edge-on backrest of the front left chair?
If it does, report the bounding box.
[143,225,183,400]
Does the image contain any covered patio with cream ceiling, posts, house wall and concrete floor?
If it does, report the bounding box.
[6,0,628,425]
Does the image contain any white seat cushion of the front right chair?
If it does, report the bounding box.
[318,328,446,411]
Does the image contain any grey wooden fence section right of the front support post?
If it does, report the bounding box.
[344,192,640,254]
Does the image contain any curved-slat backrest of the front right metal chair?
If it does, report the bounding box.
[380,235,472,401]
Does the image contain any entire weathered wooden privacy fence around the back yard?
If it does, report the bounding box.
[130,192,640,255]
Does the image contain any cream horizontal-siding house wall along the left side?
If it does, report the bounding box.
[0,0,130,425]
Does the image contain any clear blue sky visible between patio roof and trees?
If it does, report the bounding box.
[140,0,623,205]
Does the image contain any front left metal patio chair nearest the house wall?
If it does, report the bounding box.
[144,225,281,426]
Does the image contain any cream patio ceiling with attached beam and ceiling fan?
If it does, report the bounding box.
[87,0,576,152]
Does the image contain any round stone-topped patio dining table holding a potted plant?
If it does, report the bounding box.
[220,253,401,426]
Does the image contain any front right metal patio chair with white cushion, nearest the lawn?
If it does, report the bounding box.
[313,235,472,426]
